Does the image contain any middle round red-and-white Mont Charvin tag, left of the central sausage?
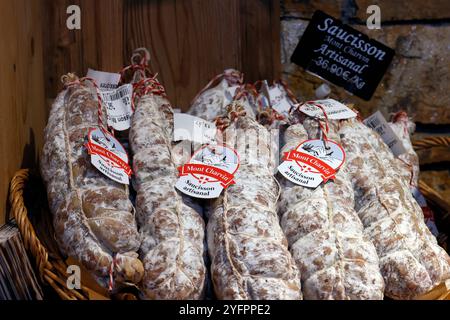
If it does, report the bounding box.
[175,145,239,199]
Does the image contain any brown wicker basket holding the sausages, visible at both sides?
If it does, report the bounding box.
[9,137,450,300]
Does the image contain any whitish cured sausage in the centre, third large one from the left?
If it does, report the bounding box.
[207,104,301,300]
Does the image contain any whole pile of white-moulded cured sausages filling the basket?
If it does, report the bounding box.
[41,71,450,299]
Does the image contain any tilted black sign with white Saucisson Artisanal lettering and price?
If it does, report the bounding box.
[291,10,395,100]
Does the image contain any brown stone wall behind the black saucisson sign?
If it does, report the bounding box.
[281,0,450,124]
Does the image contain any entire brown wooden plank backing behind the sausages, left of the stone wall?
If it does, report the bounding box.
[45,0,281,109]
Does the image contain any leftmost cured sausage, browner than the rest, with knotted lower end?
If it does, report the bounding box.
[41,75,143,287]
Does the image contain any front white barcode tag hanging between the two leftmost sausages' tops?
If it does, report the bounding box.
[100,84,133,131]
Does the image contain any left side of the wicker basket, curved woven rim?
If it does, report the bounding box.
[9,169,136,300]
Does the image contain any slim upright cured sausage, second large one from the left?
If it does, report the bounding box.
[130,80,206,299]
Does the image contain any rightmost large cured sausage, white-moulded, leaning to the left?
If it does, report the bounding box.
[339,119,450,299]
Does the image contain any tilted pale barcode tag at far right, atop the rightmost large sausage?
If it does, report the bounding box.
[364,111,406,157]
